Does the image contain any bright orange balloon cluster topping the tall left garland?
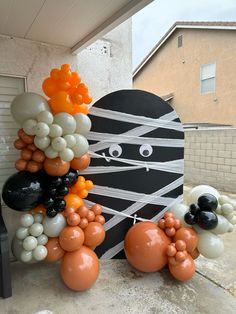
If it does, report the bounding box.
[42,64,92,114]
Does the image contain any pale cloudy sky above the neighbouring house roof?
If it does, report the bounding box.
[132,0,236,69]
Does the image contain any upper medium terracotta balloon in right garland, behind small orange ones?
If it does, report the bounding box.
[174,227,198,252]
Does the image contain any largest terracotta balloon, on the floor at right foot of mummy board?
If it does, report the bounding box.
[124,221,171,273]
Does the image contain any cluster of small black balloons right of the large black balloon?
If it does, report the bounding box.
[42,169,78,218]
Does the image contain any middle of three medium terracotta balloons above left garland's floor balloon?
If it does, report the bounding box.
[59,226,84,252]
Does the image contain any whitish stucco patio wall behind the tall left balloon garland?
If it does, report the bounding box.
[0,21,132,256]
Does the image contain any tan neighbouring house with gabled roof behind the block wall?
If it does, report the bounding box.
[133,22,236,126]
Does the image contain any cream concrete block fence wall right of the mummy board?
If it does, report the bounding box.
[184,128,236,193]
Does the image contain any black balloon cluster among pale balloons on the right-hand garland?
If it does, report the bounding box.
[184,193,218,230]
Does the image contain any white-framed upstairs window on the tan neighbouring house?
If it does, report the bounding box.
[200,63,216,94]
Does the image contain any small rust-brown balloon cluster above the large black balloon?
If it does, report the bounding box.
[14,129,45,172]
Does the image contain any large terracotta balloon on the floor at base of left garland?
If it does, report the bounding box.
[60,246,99,291]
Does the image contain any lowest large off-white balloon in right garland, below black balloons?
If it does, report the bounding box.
[197,232,224,258]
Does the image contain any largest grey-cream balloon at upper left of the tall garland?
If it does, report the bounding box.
[11,93,50,125]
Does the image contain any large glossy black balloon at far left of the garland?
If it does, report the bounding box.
[2,171,46,211]
